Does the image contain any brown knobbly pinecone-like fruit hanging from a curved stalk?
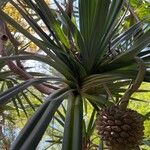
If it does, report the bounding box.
[96,106,144,150]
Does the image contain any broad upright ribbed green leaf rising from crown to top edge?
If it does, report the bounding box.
[79,0,110,72]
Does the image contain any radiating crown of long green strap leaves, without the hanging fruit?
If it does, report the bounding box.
[0,0,150,150]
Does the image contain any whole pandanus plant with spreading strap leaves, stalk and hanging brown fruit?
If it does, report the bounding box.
[0,0,150,150]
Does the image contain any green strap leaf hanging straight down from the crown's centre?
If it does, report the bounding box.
[62,96,83,150]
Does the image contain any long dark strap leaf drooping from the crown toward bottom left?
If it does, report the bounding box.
[10,87,70,150]
